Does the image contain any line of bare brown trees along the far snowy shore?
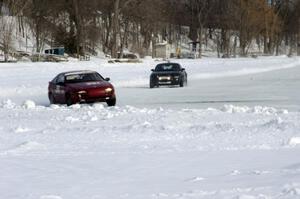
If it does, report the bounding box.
[0,0,300,57]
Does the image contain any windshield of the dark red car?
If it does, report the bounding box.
[65,73,103,84]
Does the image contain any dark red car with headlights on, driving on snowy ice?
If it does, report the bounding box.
[48,70,116,106]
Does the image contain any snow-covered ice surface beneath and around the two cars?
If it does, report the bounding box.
[0,57,300,199]
